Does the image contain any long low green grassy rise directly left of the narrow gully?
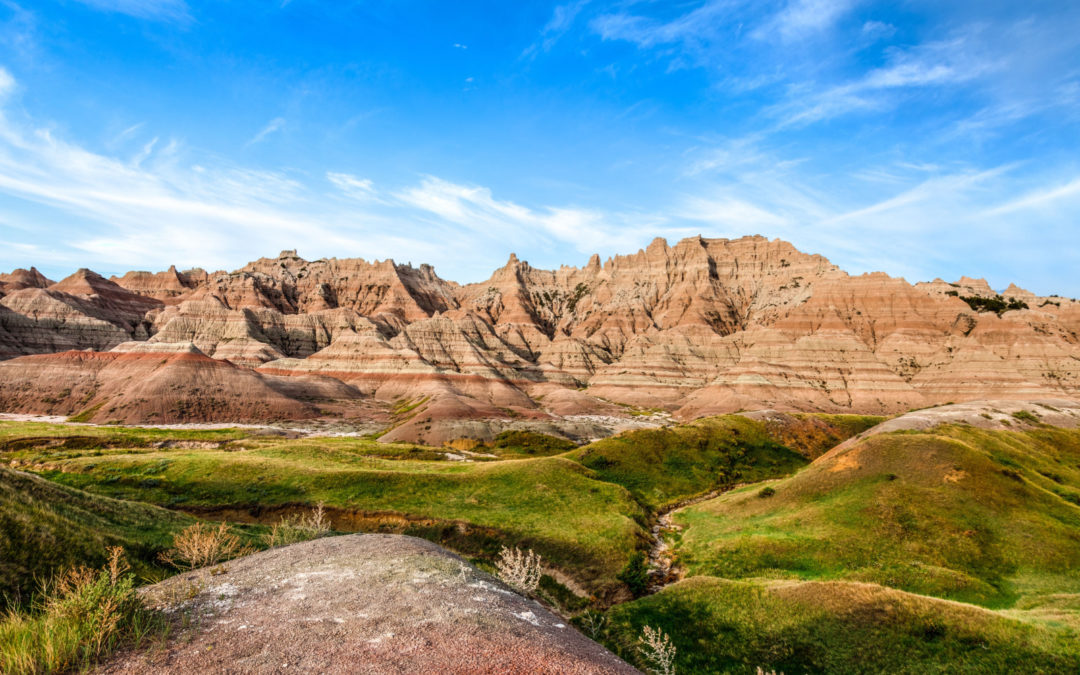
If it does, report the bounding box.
[27,438,646,591]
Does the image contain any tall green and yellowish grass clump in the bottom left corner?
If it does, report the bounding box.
[0,546,165,675]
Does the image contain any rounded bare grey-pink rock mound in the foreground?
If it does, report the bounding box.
[99,535,637,674]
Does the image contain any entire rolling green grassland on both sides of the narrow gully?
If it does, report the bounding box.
[6,415,1080,675]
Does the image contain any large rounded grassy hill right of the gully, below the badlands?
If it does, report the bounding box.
[676,426,1080,607]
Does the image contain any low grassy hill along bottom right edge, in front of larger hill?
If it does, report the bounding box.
[604,577,1080,675]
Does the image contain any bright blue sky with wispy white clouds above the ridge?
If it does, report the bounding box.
[0,0,1080,297]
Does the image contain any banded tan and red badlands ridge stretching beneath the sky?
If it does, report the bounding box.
[0,237,1080,442]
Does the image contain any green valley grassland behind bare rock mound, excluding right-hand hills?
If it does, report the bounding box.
[0,416,868,597]
